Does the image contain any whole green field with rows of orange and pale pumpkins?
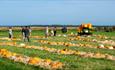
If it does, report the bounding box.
[0,29,115,70]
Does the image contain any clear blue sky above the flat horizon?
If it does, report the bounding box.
[0,0,115,25]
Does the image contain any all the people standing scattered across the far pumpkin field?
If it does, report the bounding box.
[9,26,67,42]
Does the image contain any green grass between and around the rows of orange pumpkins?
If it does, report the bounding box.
[0,30,115,70]
